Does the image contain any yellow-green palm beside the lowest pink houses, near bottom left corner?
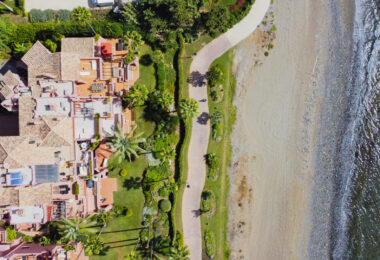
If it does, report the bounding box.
[57,215,98,241]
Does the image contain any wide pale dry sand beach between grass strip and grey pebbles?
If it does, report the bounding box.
[228,0,332,259]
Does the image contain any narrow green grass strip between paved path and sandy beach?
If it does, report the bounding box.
[201,50,236,259]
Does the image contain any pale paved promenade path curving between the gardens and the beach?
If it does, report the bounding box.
[182,0,271,260]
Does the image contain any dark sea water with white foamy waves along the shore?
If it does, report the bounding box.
[330,0,380,259]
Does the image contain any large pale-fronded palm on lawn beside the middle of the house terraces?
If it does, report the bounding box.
[107,125,146,163]
